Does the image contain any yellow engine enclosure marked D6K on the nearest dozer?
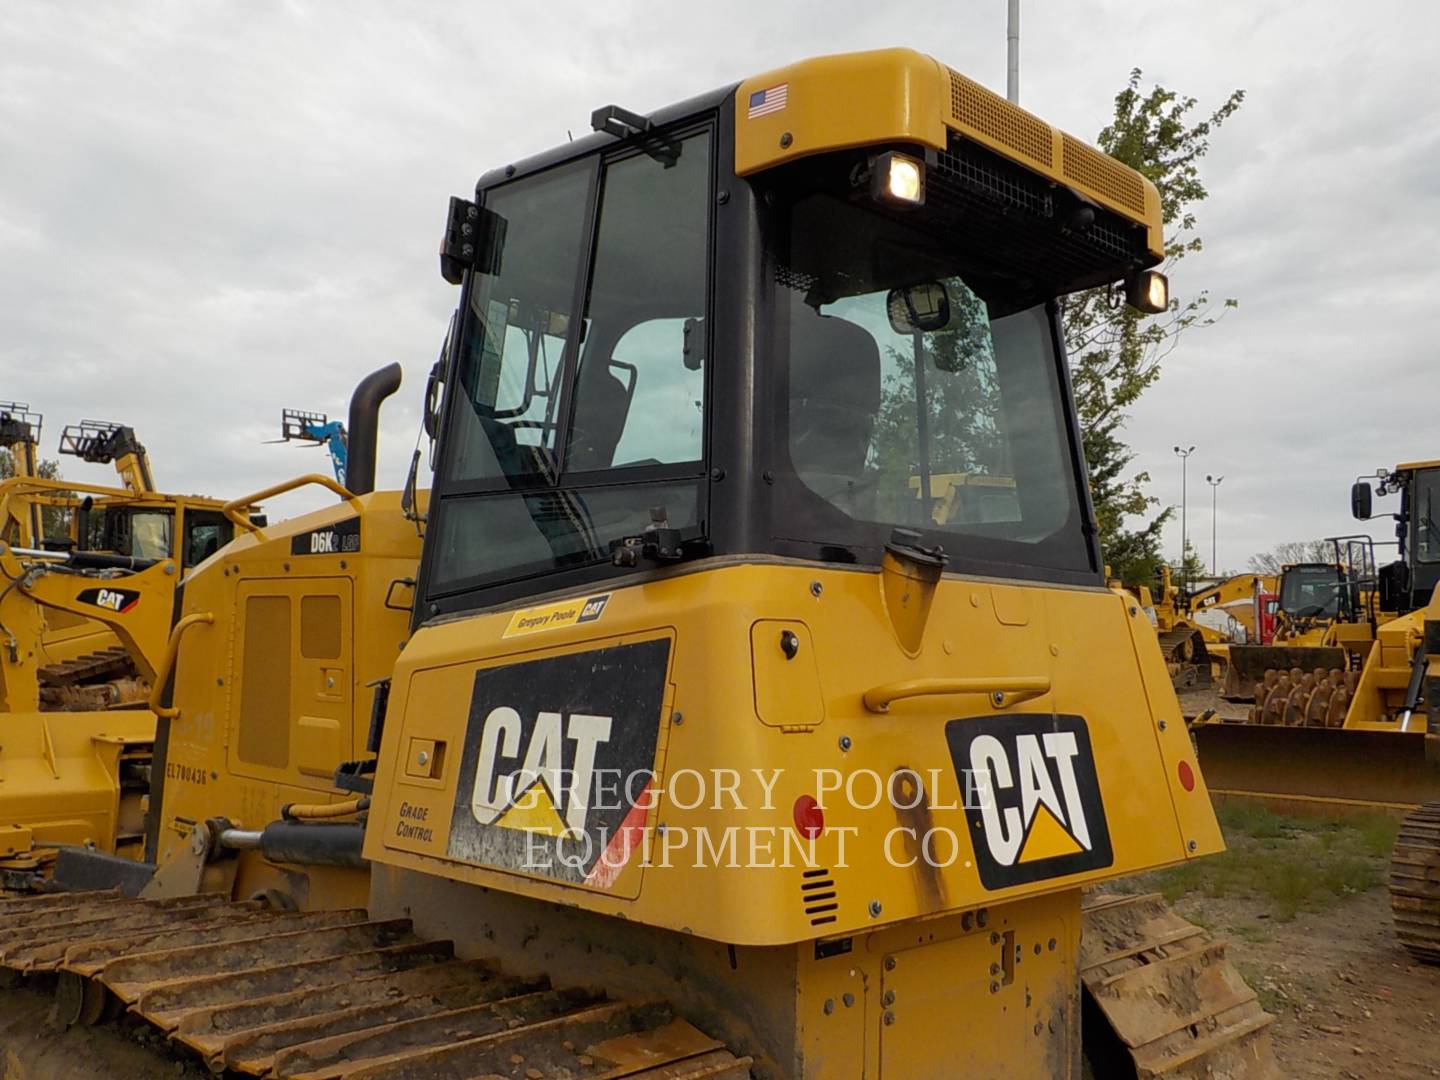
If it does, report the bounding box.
[159,491,433,907]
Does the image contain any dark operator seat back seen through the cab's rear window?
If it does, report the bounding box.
[791,304,880,520]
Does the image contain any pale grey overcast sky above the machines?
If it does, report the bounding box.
[0,0,1440,567]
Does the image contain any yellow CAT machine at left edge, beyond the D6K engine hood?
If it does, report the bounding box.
[0,413,250,888]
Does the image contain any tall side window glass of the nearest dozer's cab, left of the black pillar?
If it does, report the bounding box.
[429,131,711,595]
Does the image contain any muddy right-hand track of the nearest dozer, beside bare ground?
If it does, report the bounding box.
[1080,893,1280,1080]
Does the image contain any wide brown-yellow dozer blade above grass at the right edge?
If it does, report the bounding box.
[1191,721,1440,814]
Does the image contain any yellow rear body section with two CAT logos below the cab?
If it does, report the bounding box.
[366,563,1221,945]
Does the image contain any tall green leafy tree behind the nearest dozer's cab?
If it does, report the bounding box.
[1064,68,1244,585]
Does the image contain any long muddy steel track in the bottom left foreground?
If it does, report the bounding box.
[0,893,750,1080]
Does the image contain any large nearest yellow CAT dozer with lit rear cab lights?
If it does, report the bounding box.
[0,50,1274,1080]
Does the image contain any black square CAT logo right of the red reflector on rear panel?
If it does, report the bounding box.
[945,716,1115,888]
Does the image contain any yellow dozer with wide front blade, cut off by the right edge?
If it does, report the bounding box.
[1192,462,1440,812]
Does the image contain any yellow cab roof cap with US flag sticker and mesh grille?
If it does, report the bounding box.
[734,49,1165,259]
